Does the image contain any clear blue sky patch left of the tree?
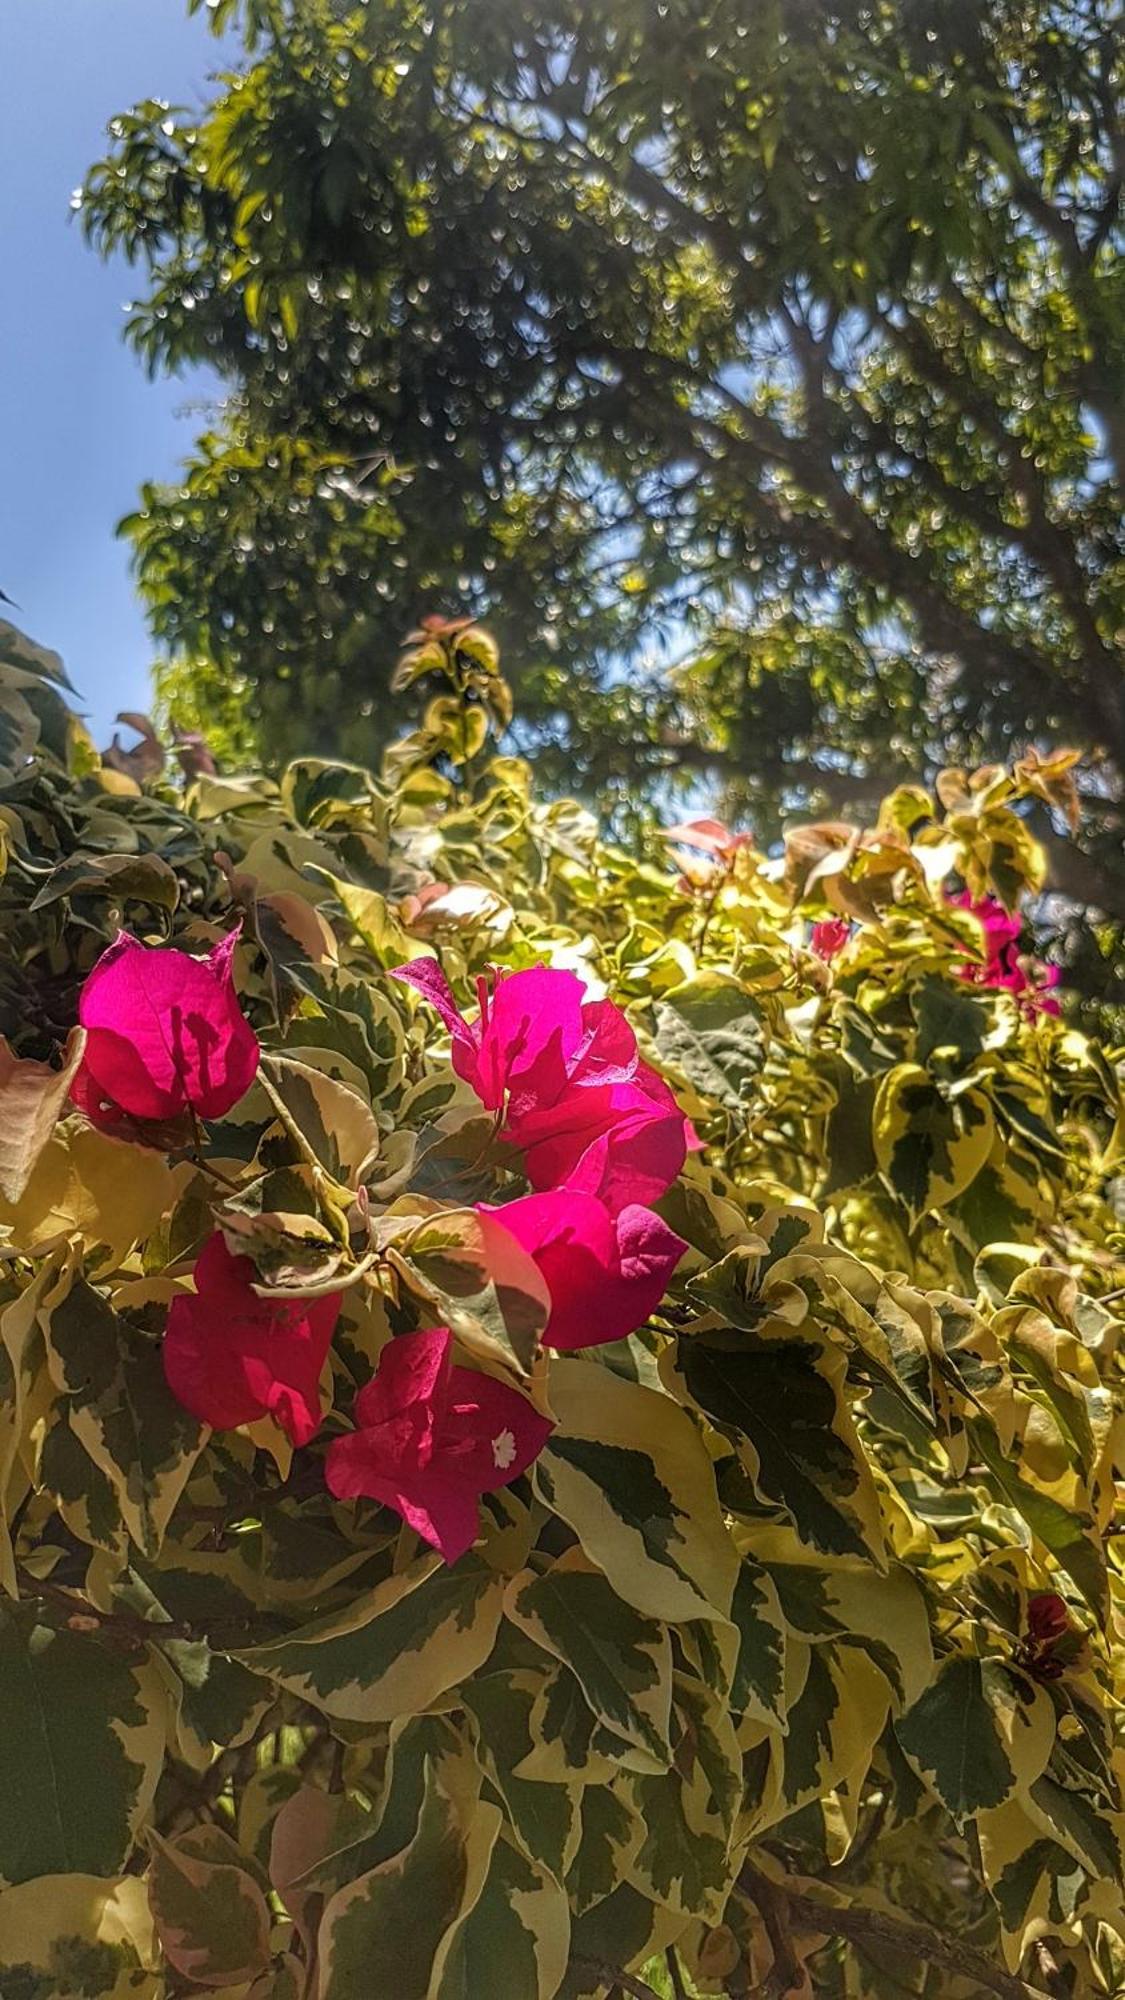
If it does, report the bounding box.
[0,0,232,742]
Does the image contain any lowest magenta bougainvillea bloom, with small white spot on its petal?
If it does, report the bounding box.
[324,1326,554,1562]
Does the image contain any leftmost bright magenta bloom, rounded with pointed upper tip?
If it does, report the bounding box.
[74,930,258,1122]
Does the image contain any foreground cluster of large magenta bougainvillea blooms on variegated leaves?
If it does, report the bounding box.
[72,932,697,1562]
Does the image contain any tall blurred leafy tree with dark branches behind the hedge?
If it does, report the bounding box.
[82,0,1125,998]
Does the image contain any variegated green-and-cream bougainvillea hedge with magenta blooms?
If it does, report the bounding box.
[0,622,1125,2000]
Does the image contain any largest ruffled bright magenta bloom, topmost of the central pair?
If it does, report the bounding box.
[394,958,695,1208]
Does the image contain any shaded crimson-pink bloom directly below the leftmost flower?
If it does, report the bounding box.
[162,1234,340,1446]
